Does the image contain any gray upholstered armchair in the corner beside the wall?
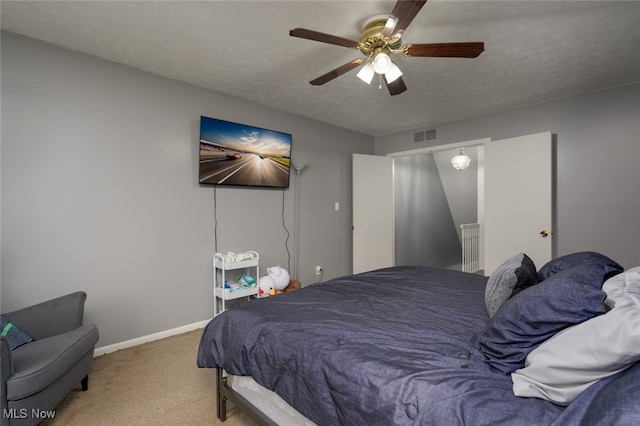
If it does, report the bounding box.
[0,292,98,426]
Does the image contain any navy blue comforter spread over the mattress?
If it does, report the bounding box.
[198,267,608,426]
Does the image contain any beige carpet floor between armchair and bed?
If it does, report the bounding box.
[41,330,255,426]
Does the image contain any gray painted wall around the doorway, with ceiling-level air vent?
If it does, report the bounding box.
[375,84,640,268]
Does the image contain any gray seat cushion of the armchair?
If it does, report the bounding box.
[7,324,99,401]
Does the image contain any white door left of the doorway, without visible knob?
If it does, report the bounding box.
[352,154,395,274]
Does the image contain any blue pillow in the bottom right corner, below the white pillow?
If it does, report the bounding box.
[581,362,640,426]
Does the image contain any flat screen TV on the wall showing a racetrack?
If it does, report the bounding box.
[199,117,291,188]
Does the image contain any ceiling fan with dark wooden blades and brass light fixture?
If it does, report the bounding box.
[289,0,484,95]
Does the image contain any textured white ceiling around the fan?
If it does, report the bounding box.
[0,0,640,135]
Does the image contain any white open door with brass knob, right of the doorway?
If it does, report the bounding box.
[484,132,552,275]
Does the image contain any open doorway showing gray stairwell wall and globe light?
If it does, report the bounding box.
[393,141,483,272]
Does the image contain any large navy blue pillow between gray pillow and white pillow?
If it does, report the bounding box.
[479,263,609,374]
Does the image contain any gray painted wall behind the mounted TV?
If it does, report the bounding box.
[0,32,374,346]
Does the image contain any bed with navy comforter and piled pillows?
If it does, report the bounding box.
[197,252,640,426]
